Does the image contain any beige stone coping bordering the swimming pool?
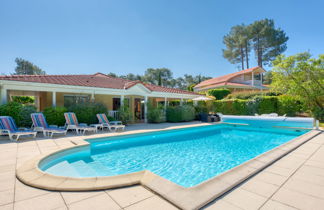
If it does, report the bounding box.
[16,123,322,209]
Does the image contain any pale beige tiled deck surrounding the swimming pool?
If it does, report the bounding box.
[0,123,324,210]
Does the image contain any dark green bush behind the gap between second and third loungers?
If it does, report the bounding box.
[43,107,68,126]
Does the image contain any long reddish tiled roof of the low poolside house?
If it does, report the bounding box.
[0,73,197,95]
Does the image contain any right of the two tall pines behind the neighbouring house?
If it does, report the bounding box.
[248,19,289,67]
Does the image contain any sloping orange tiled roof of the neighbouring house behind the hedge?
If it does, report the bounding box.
[195,66,265,88]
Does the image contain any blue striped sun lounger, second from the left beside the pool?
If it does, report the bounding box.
[31,113,67,137]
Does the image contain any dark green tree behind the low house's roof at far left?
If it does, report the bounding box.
[14,58,46,75]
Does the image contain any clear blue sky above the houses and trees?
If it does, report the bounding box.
[0,0,324,77]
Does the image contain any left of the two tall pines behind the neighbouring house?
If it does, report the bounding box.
[223,24,251,70]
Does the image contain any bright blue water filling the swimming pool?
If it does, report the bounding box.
[40,125,306,187]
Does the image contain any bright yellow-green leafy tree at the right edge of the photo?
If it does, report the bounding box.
[271,52,324,120]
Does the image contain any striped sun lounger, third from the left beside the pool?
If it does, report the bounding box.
[64,112,97,134]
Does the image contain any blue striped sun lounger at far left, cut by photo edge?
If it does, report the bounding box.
[0,116,37,141]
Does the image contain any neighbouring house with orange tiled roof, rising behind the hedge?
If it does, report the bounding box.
[194,67,268,92]
